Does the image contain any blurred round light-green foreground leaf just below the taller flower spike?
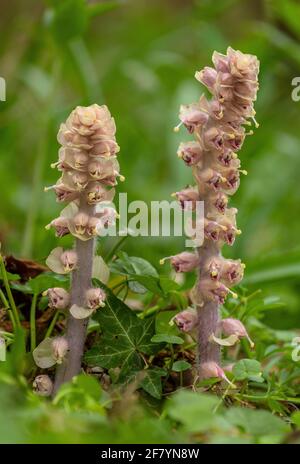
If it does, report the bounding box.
[167,390,220,433]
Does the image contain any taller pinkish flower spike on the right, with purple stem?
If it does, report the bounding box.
[166,47,259,379]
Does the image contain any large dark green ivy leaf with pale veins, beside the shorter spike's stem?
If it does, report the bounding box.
[85,280,158,375]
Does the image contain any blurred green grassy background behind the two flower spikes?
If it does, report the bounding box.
[0,0,300,329]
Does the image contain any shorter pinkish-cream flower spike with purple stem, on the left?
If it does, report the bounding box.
[43,105,124,393]
